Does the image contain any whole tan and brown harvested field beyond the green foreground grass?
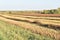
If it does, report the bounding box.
[0,14,60,40]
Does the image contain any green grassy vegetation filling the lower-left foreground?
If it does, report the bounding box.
[0,20,54,40]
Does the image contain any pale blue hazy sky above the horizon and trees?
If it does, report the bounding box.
[0,0,60,10]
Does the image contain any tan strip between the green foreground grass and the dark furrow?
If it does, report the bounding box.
[0,16,60,40]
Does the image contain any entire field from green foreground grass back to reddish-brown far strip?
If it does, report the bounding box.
[0,13,60,40]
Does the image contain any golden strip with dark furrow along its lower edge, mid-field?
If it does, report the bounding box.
[0,15,60,30]
